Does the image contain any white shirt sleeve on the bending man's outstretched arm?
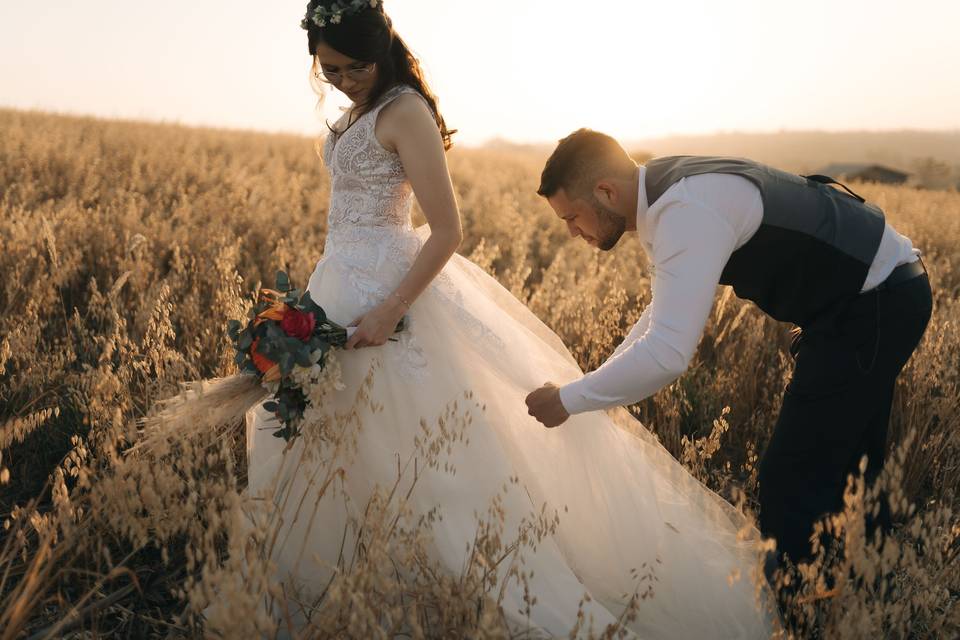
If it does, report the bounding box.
[560,199,737,414]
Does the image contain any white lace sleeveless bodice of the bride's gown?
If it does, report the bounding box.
[323,85,419,236]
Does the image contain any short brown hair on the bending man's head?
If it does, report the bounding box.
[537,129,637,198]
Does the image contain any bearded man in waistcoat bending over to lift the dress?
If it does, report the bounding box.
[527,129,931,576]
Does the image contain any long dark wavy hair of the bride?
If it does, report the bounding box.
[307,0,456,149]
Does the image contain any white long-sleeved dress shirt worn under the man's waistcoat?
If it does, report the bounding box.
[560,166,920,414]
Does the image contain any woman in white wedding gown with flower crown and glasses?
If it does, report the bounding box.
[247,0,774,638]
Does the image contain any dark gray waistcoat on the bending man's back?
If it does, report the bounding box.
[645,156,884,326]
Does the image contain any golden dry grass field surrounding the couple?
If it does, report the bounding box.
[0,110,960,640]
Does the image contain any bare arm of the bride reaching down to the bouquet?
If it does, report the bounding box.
[347,94,463,349]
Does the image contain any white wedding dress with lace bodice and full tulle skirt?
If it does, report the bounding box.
[247,87,773,638]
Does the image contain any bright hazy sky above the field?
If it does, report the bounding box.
[0,0,960,143]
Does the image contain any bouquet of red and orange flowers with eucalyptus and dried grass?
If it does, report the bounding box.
[140,271,404,448]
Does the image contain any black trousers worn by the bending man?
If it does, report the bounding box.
[759,273,932,568]
